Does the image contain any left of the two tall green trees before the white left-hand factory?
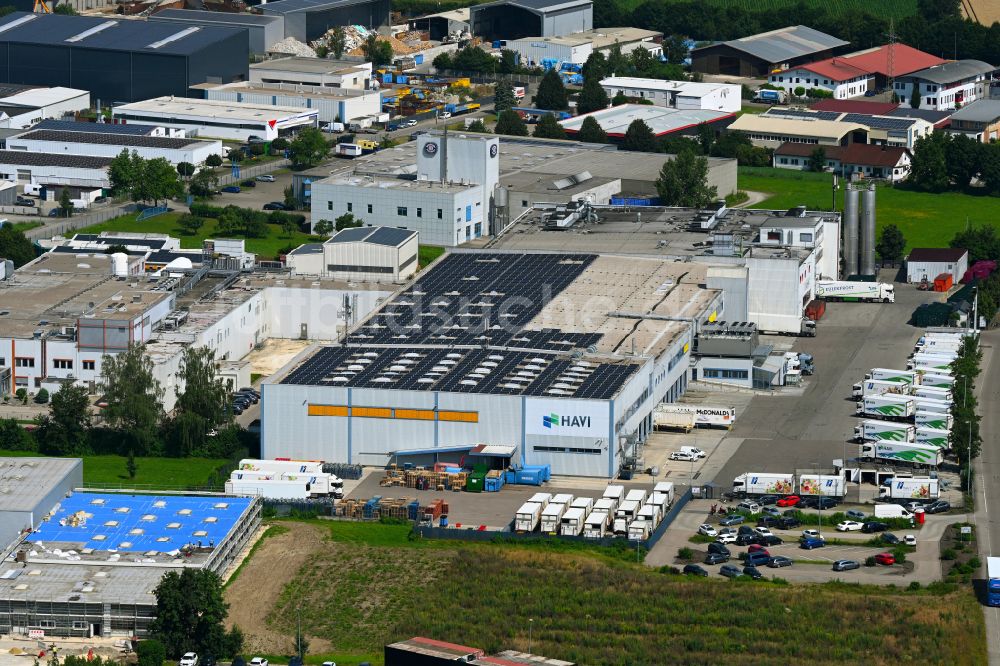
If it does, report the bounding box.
[101,344,163,455]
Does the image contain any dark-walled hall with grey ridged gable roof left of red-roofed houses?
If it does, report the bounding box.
[691,25,848,78]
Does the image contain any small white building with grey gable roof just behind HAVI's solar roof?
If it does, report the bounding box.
[285,227,420,282]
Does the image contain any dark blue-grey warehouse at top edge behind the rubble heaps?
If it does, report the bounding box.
[259,0,390,42]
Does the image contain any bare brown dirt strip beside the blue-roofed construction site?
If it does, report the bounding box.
[225,522,326,654]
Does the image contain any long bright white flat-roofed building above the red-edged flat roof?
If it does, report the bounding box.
[601,76,742,113]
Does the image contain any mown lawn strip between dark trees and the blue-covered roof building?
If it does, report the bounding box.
[0,451,226,490]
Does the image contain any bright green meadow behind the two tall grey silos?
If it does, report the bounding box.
[739,167,1000,250]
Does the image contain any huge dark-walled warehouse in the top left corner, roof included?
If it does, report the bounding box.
[0,12,250,105]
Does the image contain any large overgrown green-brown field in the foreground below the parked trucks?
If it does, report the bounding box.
[254,522,986,665]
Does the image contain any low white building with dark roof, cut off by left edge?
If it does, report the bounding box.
[0,150,111,189]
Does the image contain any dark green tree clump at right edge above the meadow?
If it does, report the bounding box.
[908,132,1000,195]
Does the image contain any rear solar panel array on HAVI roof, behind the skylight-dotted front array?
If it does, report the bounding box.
[350,253,600,351]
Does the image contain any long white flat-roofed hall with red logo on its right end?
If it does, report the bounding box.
[112,97,319,141]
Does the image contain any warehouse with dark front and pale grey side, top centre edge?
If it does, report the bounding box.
[470,0,594,41]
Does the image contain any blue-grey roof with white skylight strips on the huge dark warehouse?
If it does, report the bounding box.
[0,12,243,55]
